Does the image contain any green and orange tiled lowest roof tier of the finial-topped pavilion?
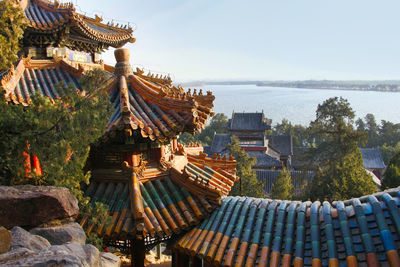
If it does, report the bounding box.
[80,177,215,240]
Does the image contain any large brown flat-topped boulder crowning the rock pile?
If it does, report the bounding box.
[0,185,79,229]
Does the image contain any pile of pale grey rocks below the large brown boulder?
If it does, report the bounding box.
[0,223,121,267]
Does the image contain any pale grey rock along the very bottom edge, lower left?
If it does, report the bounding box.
[1,243,100,267]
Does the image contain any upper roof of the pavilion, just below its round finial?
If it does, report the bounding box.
[106,58,215,141]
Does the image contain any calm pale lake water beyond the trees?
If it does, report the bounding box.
[203,85,400,125]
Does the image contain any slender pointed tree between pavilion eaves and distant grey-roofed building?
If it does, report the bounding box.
[228,136,264,197]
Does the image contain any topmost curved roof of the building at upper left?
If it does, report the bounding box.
[20,0,135,52]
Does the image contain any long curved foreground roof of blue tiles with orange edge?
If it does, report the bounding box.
[176,188,400,267]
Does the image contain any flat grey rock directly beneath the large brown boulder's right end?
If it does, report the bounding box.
[29,222,86,245]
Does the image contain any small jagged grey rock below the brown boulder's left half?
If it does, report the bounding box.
[11,226,50,252]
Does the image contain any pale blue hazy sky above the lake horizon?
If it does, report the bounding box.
[74,0,400,81]
